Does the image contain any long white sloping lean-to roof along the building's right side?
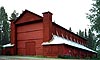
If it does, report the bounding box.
[42,35,97,53]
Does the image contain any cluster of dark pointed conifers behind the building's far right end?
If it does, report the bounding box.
[77,29,96,50]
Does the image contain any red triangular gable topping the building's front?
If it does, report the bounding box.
[14,10,42,24]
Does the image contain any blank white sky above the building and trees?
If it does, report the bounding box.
[0,0,93,33]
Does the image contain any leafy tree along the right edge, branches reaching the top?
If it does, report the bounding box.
[87,0,100,51]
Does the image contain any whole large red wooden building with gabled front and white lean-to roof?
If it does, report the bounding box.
[3,10,96,58]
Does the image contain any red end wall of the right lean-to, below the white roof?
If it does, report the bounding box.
[43,45,64,57]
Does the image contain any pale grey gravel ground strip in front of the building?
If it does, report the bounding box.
[0,56,68,60]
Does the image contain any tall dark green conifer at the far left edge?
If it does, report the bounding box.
[0,7,9,45]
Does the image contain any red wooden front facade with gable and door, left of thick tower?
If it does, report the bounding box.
[11,10,43,55]
